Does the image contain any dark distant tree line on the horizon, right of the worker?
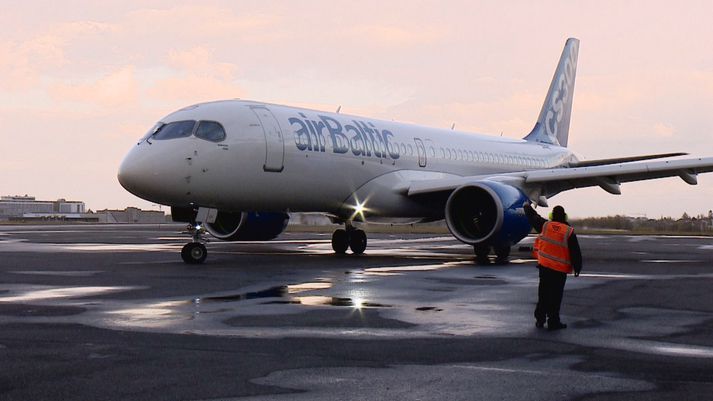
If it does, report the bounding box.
[571,211,713,234]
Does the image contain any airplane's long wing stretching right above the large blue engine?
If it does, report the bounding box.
[408,157,713,197]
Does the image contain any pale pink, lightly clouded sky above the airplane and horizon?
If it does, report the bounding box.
[0,0,713,217]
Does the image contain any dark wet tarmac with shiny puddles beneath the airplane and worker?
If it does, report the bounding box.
[0,225,713,400]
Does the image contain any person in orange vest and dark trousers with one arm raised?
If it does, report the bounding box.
[524,202,582,330]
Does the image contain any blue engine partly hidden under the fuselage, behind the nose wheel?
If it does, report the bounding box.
[205,211,290,241]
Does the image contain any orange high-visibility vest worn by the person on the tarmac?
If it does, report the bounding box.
[536,221,574,273]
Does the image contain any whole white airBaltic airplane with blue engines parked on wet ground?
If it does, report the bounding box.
[118,38,713,264]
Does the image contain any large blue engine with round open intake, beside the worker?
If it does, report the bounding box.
[445,180,531,247]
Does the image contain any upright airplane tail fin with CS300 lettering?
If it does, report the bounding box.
[525,38,579,147]
